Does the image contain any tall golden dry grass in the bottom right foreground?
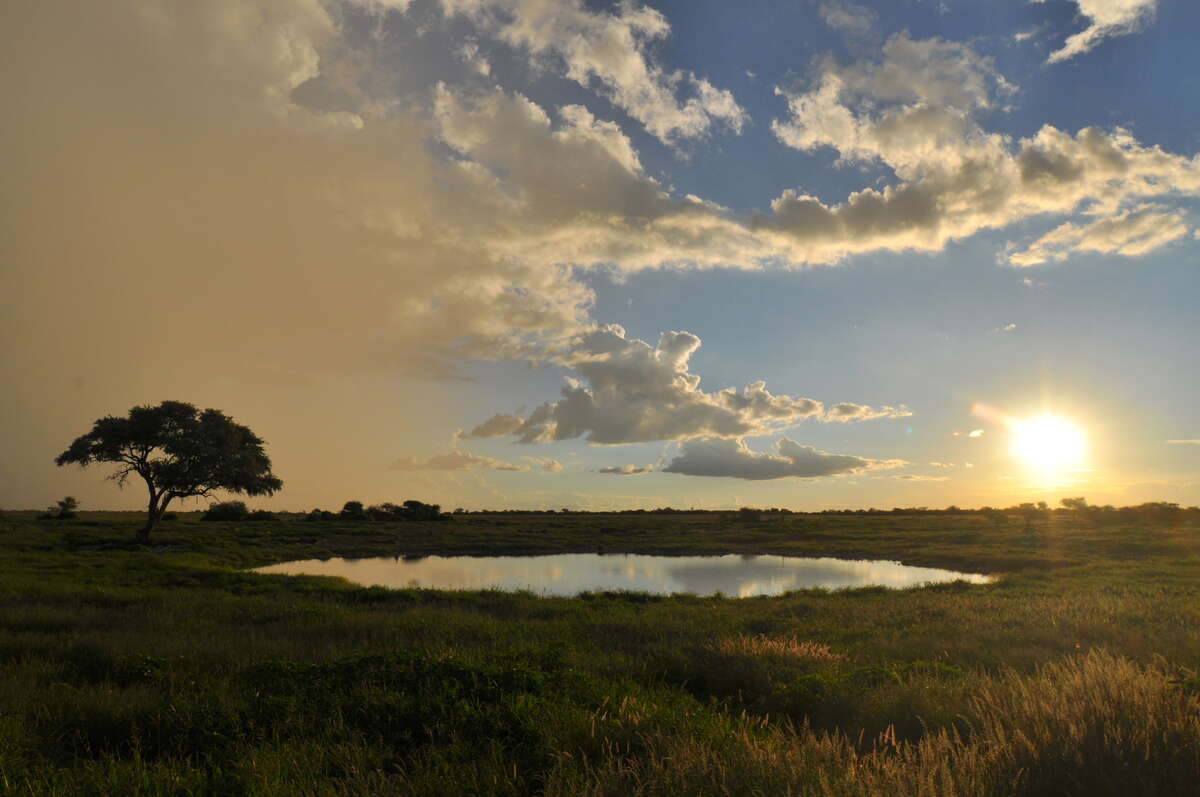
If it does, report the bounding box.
[546,651,1200,797]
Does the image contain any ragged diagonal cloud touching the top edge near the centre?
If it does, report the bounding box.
[442,0,748,144]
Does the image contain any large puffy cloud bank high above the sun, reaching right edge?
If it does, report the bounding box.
[768,34,1200,262]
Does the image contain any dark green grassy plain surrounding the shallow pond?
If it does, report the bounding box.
[0,513,1200,796]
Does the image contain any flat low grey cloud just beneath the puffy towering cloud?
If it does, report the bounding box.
[662,437,907,480]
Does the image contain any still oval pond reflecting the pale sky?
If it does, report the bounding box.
[256,553,990,598]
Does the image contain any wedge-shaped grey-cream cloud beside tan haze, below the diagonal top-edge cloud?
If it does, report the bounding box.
[433,85,779,272]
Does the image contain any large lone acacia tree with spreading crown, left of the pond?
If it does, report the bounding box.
[54,401,283,543]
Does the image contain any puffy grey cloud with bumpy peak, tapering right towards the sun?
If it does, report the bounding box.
[467,325,911,444]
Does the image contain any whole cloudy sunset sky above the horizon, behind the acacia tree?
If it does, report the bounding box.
[0,0,1200,510]
